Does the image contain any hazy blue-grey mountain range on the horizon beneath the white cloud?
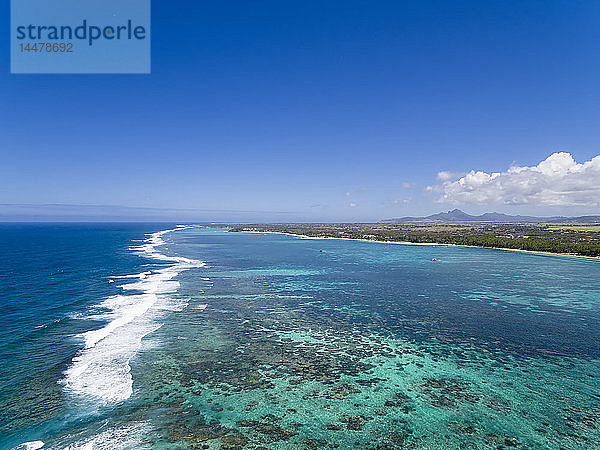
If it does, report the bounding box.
[379,209,600,224]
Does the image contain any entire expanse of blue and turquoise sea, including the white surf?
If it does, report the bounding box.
[0,225,600,449]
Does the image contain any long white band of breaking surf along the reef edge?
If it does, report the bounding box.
[62,226,205,405]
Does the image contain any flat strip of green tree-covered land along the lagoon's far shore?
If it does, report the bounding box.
[224,223,600,257]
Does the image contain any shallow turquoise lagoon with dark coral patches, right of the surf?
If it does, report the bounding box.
[134,231,600,448]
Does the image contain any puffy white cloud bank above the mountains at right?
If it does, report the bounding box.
[427,152,600,207]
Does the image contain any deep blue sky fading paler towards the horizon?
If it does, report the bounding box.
[0,0,600,221]
